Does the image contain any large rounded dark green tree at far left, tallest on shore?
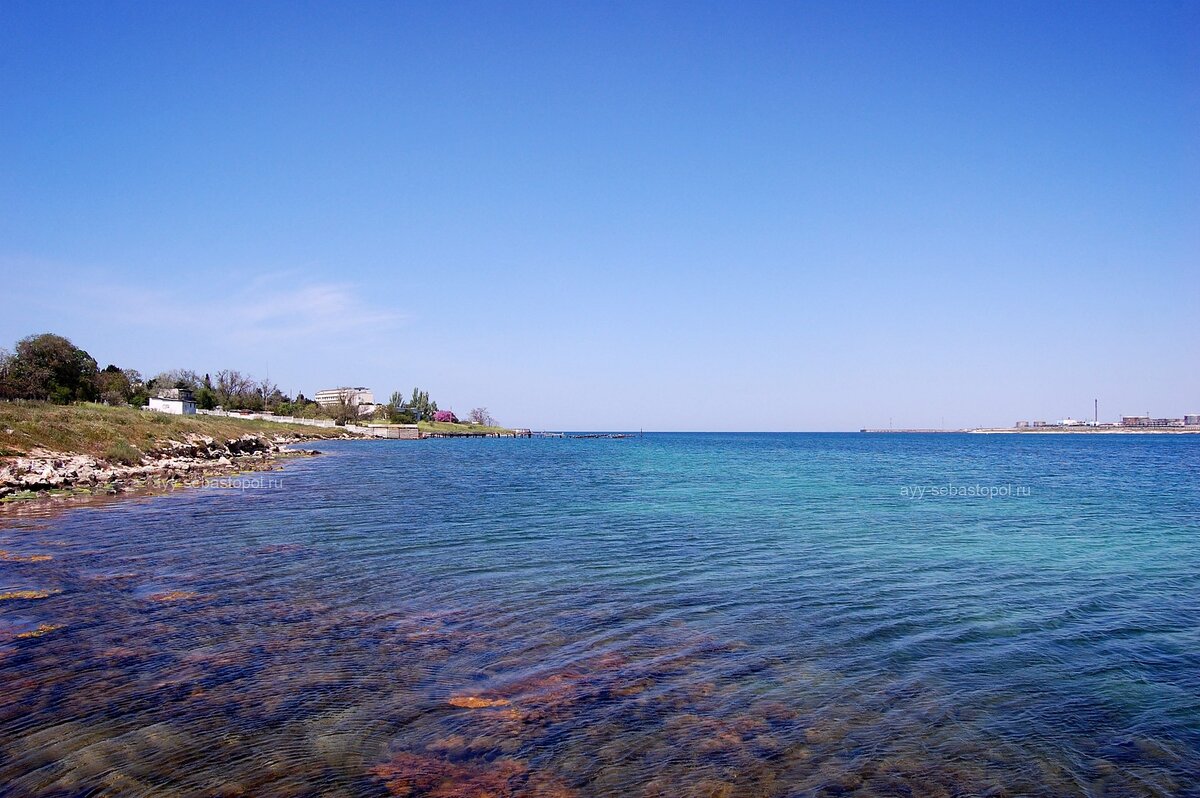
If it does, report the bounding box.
[2,332,100,404]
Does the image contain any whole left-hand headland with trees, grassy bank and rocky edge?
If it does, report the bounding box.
[0,332,520,504]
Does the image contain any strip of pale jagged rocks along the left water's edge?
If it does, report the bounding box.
[0,434,319,503]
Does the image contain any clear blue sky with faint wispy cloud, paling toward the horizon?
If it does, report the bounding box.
[0,0,1200,430]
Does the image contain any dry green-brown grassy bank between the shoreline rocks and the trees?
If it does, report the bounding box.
[0,402,343,462]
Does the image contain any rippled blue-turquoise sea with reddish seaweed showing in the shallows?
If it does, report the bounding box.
[0,434,1200,796]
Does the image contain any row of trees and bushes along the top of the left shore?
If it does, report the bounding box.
[0,332,496,425]
